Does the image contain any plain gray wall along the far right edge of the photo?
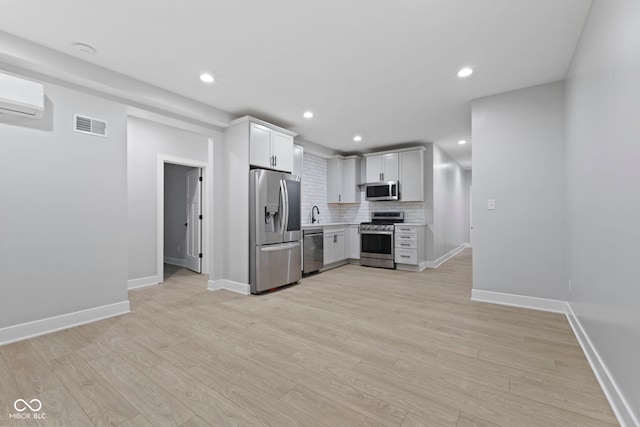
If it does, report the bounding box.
[564,0,640,419]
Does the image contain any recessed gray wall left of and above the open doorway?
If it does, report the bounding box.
[127,117,212,280]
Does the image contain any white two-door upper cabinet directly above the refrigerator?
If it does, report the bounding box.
[249,123,293,172]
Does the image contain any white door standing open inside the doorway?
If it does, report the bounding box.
[185,168,202,273]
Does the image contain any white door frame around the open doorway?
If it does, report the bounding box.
[156,154,212,283]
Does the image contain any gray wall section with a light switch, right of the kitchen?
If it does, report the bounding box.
[472,82,569,300]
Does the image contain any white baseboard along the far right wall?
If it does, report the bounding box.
[566,303,640,427]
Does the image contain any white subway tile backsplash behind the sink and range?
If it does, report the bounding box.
[302,153,433,224]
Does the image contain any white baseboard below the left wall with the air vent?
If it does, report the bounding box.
[0,301,129,345]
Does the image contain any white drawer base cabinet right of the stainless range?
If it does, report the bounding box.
[394,224,426,270]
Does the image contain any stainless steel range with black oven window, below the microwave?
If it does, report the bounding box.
[360,212,404,268]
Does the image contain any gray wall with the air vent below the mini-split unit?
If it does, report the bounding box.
[0,80,127,328]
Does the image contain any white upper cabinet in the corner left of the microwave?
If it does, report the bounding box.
[327,156,360,203]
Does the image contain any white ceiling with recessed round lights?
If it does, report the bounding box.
[0,0,591,168]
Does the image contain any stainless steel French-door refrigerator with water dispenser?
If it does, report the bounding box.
[249,169,302,294]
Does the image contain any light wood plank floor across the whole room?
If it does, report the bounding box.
[0,250,618,427]
